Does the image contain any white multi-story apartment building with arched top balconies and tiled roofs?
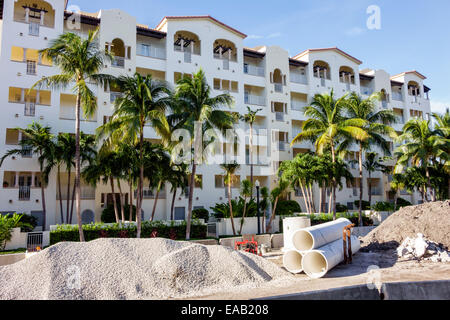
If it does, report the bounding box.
[0,0,430,228]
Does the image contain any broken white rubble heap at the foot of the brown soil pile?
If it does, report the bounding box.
[397,233,450,262]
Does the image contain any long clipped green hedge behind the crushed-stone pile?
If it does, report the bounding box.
[50,221,207,245]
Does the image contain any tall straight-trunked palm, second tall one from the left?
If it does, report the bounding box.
[97,73,171,238]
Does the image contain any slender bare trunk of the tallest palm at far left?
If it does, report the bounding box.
[75,91,85,242]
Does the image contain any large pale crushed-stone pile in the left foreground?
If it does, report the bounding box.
[0,239,291,300]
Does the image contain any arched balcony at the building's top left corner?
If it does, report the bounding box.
[14,0,55,36]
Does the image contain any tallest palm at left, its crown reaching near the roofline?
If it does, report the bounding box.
[33,29,112,242]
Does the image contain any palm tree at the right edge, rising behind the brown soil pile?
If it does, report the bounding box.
[395,119,449,202]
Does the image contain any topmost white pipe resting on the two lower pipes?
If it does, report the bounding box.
[292,218,352,252]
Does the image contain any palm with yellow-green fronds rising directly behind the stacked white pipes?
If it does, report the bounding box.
[291,91,368,218]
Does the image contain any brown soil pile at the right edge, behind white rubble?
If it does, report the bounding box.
[363,201,450,251]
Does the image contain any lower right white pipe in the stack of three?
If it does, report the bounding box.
[302,236,361,279]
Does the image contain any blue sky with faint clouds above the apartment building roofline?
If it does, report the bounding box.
[69,0,450,111]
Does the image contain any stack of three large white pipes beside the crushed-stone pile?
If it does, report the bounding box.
[283,218,361,279]
